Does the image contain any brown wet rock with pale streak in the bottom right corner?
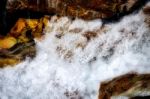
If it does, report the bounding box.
[99,74,150,99]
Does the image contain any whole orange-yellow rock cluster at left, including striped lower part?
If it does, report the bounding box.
[0,16,49,68]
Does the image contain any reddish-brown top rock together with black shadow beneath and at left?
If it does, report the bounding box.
[0,0,148,35]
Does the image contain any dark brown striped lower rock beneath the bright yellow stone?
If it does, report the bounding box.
[0,41,36,68]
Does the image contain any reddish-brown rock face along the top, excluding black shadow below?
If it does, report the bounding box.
[7,0,147,19]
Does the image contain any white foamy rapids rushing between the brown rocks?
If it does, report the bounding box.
[0,6,150,99]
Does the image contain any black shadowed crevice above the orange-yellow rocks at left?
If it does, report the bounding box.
[0,10,54,35]
